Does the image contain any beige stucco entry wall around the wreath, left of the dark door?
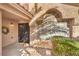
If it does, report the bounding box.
[2,19,18,47]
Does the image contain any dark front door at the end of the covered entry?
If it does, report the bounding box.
[18,23,30,43]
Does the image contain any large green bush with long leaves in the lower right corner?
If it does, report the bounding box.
[51,36,79,56]
